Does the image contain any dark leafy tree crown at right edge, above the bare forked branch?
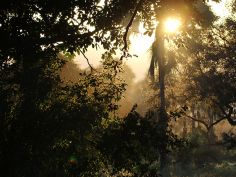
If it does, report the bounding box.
[184,20,236,125]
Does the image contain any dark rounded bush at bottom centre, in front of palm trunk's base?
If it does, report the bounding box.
[99,106,184,177]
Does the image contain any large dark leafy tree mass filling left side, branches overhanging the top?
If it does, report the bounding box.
[0,0,227,177]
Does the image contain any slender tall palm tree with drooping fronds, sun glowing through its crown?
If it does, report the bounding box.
[149,1,217,171]
